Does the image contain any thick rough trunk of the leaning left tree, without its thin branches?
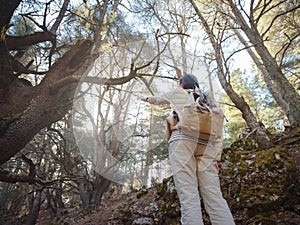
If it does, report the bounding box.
[0,41,92,165]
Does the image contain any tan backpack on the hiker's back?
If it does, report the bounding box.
[181,91,224,141]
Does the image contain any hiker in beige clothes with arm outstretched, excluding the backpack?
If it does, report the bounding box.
[140,74,235,225]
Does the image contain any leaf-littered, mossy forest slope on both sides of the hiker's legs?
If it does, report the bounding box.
[37,128,300,225]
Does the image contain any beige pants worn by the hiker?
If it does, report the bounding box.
[169,140,235,225]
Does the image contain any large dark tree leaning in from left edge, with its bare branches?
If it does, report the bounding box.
[0,0,142,165]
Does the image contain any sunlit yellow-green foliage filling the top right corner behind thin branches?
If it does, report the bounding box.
[258,0,300,80]
